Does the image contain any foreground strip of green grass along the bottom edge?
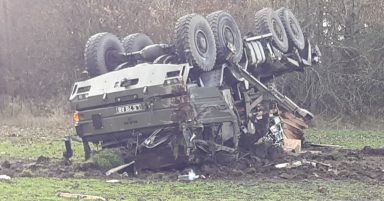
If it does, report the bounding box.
[0,178,384,201]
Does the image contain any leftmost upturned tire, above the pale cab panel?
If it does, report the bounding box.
[84,32,124,77]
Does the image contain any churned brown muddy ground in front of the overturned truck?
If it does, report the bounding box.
[0,146,384,183]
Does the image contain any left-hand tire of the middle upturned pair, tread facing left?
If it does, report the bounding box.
[175,13,216,71]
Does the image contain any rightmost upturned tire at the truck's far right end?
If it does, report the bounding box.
[276,8,305,50]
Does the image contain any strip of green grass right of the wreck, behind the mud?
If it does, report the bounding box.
[305,129,384,149]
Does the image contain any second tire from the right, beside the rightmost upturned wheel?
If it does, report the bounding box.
[255,8,289,53]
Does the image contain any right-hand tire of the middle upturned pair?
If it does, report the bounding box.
[207,10,243,64]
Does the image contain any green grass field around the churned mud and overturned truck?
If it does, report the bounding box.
[0,129,384,200]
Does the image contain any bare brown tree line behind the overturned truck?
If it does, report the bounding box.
[0,0,384,124]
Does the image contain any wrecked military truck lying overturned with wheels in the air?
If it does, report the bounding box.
[65,8,320,169]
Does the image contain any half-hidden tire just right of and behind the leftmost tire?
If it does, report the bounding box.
[122,33,153,53]
